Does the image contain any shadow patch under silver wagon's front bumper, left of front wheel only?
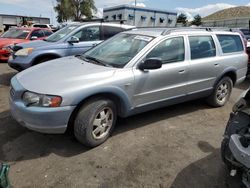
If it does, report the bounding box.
[0,111,88,162]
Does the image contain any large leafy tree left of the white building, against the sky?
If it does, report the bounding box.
[54,0,97,22]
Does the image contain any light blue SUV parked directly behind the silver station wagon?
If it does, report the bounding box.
[9,22,134,71]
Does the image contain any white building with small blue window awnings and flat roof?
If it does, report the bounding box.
[103,5,177,27]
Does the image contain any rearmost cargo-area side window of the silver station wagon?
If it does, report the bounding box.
[217,35,244,53]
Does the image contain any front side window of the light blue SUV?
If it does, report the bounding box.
[73,26,101,42]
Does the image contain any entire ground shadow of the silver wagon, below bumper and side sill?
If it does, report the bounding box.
[0,100,210,162]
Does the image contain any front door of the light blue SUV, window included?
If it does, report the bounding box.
[66,26,102,56]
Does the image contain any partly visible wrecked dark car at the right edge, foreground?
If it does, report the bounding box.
[221,90,250,187]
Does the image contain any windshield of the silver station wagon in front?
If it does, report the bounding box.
[84,33,153,68]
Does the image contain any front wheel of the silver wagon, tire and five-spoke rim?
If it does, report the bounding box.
[74,98,117,147]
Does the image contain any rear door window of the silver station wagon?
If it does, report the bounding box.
[188,36,216,59]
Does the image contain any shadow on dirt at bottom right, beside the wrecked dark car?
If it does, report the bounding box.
[170,141,242,188]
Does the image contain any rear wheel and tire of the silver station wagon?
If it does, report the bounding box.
[207,76,233,107]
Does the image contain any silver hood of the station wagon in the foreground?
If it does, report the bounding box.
[16,56,116,96]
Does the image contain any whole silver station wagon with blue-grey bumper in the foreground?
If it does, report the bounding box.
[10,29,247,147]
